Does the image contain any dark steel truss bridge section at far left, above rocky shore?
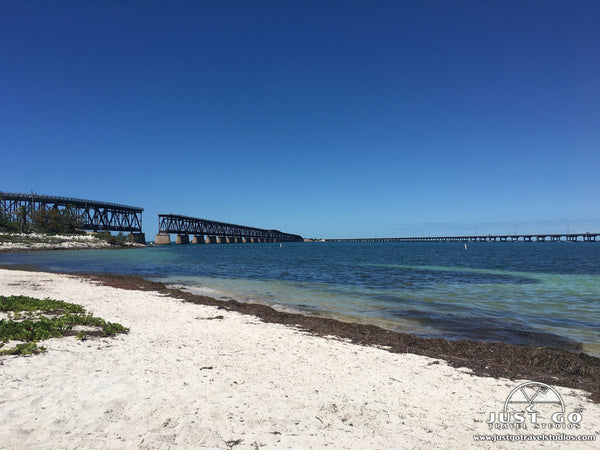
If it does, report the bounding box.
[0,192,144,233]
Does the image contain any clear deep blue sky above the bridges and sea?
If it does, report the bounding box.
[0,0,600,239]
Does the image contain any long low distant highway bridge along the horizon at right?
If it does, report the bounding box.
[325,233,600,242]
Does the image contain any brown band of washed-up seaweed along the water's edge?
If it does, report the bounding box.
[9,266,600,403]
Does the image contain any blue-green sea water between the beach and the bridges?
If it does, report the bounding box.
[0,242,600,356]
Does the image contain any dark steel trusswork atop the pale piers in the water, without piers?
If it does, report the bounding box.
[158,214,304,242]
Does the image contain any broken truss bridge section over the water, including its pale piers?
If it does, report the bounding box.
[156,214,304,244]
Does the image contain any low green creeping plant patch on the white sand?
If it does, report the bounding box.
[0,295,129,356]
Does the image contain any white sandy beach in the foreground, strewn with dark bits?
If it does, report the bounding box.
[0,270,600,449]
